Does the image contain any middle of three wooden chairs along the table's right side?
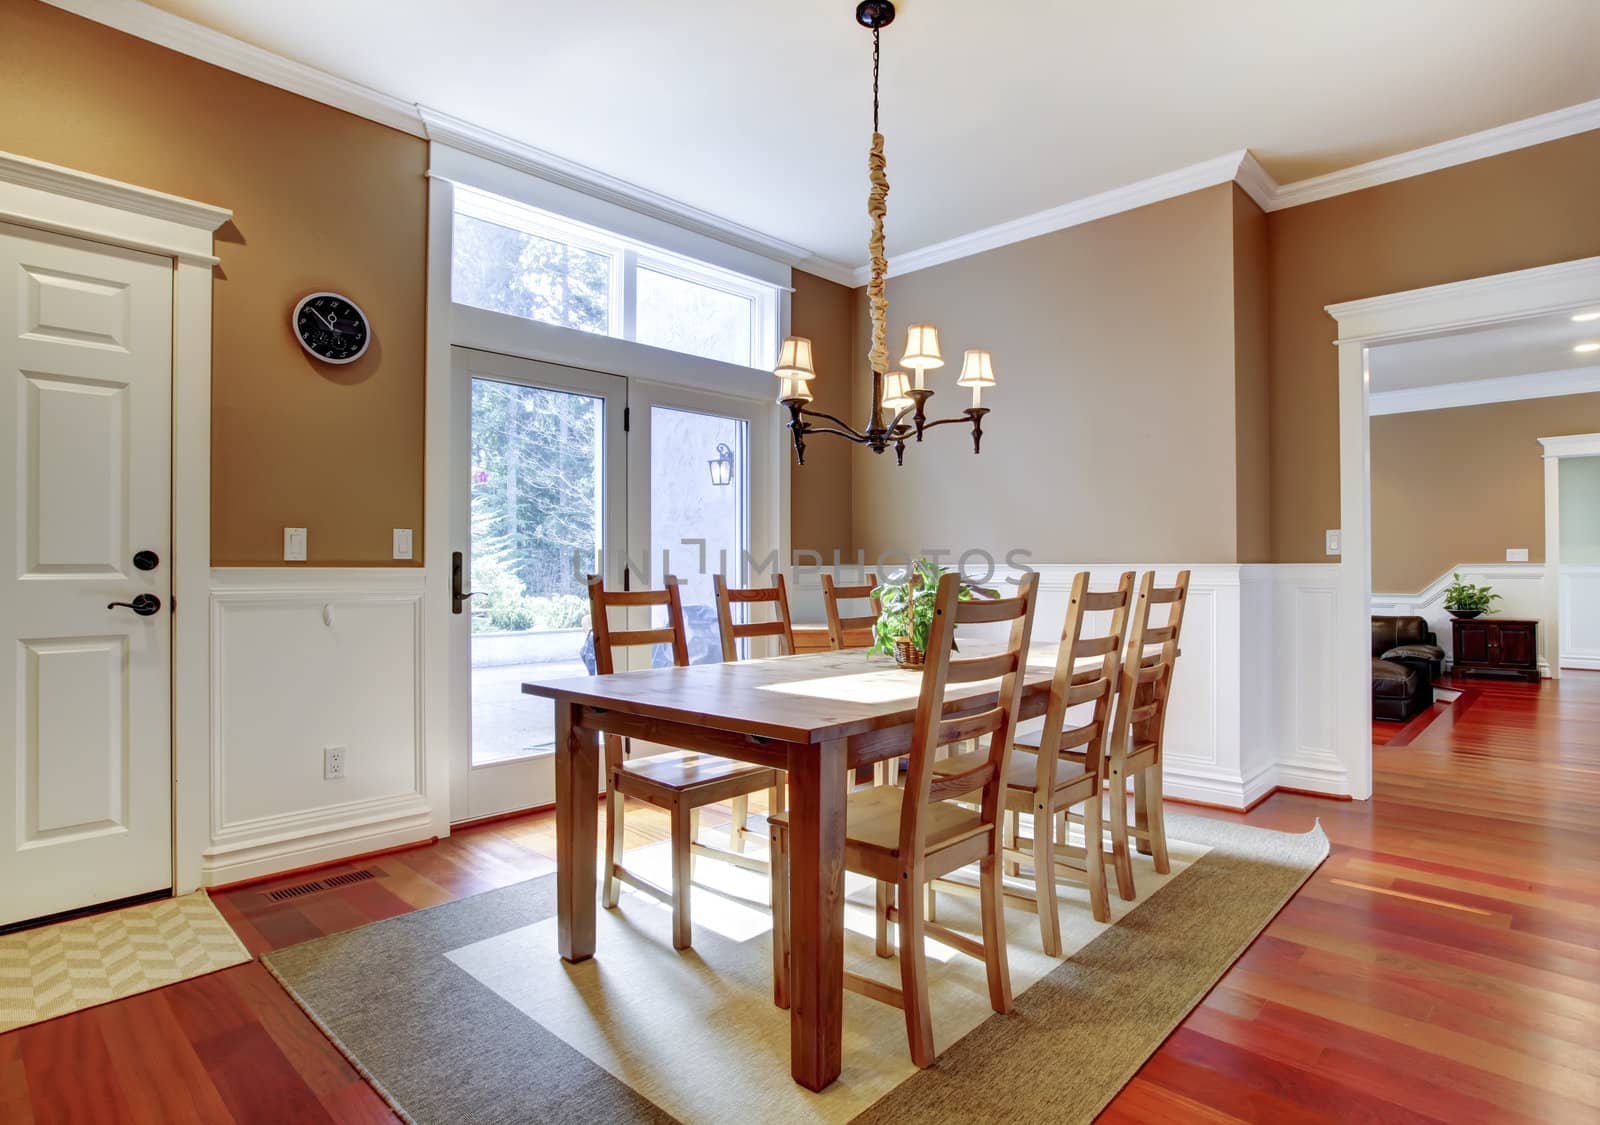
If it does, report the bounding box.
[934,570,1133,957]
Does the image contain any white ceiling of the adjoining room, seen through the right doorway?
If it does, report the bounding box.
[1366,309,1600,394]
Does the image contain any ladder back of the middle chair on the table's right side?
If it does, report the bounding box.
[1034,570,1133,792]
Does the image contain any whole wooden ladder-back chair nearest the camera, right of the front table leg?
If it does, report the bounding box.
[770,575,1038,1066]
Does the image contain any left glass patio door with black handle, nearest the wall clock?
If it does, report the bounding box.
[450,347,627,821]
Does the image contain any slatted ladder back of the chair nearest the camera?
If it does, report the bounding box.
[899,573,1038,856]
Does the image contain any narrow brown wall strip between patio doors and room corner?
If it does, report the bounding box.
[773,270,856,563]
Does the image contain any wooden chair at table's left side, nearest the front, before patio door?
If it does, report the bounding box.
[589,575,782,949]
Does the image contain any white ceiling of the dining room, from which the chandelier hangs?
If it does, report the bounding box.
[140,0,1600,266]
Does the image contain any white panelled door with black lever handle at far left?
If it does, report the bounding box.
[0,224,175,925]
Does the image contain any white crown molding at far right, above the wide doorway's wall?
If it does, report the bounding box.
[1256,99,1600,211]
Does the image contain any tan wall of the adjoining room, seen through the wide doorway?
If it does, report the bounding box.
[1371,394,1600,594]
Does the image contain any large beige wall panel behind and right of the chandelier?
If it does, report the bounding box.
[854,184,1254,562]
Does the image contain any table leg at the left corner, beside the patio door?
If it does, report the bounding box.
[555,699,600,962]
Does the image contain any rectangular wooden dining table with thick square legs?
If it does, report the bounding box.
[522,642,1056,1090]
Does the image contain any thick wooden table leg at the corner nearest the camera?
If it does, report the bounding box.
[789,739,848,1090]
